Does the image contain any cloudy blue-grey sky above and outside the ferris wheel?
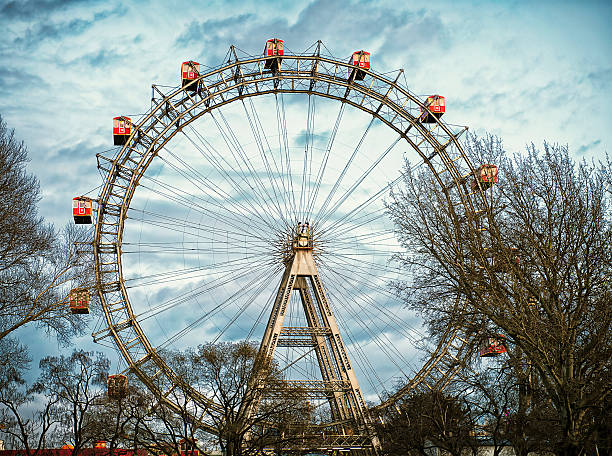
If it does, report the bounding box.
[0,0,612,402]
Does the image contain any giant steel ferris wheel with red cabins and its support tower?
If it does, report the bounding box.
[83,39,486,450]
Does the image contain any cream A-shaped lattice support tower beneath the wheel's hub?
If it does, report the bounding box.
[253,223,380,454]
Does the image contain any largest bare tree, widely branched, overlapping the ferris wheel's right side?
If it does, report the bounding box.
[388,136,612,455]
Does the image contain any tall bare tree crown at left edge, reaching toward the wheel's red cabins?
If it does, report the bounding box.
[0,117,90,342]
